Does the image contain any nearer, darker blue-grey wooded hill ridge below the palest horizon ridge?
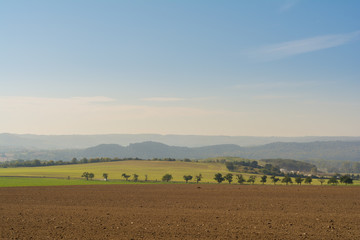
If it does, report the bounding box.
[4,141,360,161]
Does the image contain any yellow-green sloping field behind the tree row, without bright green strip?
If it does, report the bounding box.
[0,160,235,182]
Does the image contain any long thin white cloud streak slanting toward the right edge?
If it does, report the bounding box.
[249,31,360,61]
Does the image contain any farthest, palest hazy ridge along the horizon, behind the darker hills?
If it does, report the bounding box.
[0,133,360,150]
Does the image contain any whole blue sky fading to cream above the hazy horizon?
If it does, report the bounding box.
[0,0,360,136]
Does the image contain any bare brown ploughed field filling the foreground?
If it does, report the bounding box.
[0,184,360,239]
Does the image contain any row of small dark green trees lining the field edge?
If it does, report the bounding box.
[81,172,359,185]
